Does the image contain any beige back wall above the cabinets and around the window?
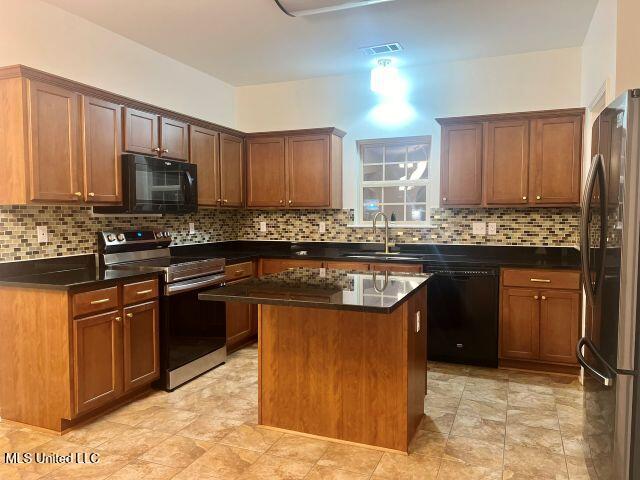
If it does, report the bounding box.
[236,48,581,208]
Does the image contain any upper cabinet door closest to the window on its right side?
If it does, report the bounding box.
[440,123,482,206]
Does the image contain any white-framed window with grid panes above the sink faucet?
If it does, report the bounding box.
[357,136,431,224]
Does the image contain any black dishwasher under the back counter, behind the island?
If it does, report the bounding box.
[424,265,499,367]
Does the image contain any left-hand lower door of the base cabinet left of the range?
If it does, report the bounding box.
[73,311,122,414]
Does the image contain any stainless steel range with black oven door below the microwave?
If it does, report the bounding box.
[98,230,227,391]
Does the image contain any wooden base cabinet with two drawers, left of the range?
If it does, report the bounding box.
[0,275,160,432]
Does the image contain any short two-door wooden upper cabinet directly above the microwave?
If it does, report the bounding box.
[124,108,189,162]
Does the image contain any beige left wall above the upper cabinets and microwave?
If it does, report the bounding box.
[0,0,235,127]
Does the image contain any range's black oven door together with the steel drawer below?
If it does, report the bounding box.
[160,275,227,390]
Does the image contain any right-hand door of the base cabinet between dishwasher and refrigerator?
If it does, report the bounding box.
[540,290,580,364]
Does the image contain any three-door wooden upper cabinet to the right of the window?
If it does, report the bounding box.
[438,109,584,206]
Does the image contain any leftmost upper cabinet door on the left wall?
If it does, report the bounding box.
[28,80,82,202]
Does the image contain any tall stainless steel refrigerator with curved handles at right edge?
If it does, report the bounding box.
[576,89,640,480]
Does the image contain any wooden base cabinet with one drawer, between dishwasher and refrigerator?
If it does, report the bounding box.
[500,269,580,372]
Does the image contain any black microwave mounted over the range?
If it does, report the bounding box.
[94,154,198,214]
